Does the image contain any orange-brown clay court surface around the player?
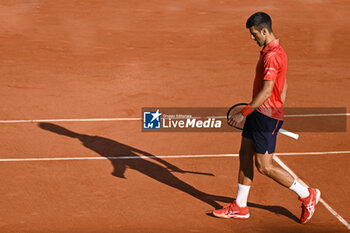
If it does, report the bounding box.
[0,0,350,233]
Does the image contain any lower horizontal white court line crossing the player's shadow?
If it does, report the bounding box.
[0,151,350,162]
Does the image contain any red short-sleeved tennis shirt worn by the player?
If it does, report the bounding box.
[253,39,288,120]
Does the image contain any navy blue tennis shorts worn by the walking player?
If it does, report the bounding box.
[242,111,283,154]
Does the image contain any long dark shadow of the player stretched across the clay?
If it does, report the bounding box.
[39,123,298,221]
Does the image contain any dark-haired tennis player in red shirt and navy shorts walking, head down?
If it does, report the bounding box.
[213,12,321,223]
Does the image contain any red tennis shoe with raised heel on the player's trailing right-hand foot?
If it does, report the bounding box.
[299,188,321,224]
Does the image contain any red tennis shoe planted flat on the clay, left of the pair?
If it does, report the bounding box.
[213,201,250,219]
